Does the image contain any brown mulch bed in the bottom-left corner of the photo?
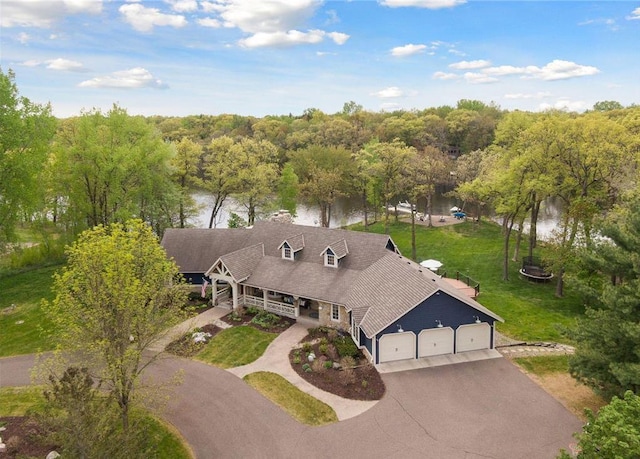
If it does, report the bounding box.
[0,416,56,458]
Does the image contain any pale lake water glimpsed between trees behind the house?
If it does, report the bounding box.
[189,191,561,239]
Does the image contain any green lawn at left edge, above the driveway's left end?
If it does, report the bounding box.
[0,266,60,357]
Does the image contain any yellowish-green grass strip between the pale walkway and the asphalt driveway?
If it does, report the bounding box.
[243,371,338,426]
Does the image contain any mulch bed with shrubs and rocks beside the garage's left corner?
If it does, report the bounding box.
[289,327,385,400]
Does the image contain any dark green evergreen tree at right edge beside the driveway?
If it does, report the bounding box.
[569,193,640,397]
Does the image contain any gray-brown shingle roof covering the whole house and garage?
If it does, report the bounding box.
[162,221,502,337]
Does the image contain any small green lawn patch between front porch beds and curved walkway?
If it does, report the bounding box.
[196,325,278,368]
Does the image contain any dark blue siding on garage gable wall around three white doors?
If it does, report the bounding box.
[376,291,495,363]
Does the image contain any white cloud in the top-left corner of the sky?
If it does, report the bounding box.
[0,0,102,28]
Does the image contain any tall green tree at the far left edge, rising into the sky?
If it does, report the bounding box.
[0,69,56,248]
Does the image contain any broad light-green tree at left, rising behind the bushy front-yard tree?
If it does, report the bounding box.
[54,106,177,232]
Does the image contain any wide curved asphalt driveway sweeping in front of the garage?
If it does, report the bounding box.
[0,356,582,459]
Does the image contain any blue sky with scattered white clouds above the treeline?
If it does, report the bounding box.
[0,0,640,117]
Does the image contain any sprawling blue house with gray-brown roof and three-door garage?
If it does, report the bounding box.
[162,221,502,364]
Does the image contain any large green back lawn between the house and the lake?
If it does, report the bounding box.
[351,221,584,342]
